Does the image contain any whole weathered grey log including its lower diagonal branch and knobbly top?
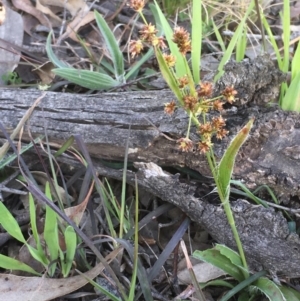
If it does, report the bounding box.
[0,55,300,277]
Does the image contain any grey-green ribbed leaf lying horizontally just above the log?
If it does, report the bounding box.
[52,68,120,90]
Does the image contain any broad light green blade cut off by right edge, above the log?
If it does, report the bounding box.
[281,72,300,112]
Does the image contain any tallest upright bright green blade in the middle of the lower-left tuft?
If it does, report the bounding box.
[44,182,59,264]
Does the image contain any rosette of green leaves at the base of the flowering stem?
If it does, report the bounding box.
[193,244,300,301]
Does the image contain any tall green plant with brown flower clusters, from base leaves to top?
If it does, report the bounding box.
[126,1,298,301]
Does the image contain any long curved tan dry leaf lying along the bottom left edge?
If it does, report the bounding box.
[0,248,122,301]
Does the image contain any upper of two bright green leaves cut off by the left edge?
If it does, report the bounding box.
[0,202,26,243]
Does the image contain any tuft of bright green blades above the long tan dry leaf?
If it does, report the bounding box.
[0,179,77,277]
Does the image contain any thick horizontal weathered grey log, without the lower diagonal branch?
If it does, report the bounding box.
[0,90,300,200]
